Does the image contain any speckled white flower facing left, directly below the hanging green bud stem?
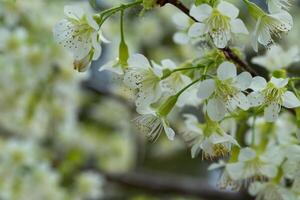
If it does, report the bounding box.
[124,54,163,113]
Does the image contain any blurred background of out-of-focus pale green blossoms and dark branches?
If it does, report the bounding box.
[0,0,300,200]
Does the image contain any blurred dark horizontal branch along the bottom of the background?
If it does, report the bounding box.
[103,172,250,200]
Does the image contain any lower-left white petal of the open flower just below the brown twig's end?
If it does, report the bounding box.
[207,98,226,121]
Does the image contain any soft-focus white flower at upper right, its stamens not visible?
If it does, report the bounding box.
[252,45,300,71]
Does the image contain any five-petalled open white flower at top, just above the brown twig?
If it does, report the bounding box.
[188,1,248,48]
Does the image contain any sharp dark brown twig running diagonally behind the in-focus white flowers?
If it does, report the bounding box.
[157,0,258,76]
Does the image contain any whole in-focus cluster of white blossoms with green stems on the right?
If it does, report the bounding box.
[45,0,300,200]
